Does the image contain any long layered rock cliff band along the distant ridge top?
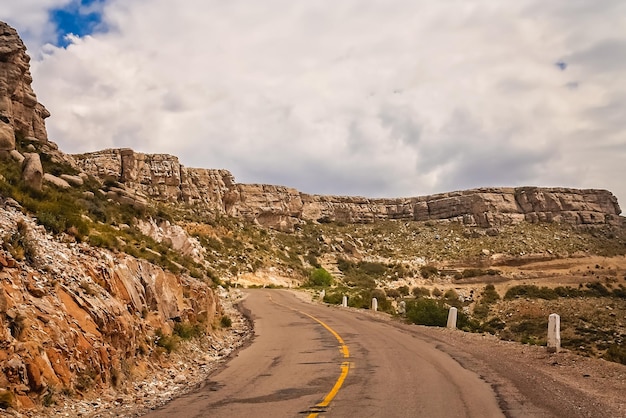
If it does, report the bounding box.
[74,149,621,230]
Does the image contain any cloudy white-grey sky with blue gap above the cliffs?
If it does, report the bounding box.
[0,0,626,206]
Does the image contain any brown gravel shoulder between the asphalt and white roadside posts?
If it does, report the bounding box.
[336,296,626,418]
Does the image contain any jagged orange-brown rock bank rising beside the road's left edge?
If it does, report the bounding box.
[0,207,221,408]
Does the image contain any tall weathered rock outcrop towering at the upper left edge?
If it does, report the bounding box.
[0,22,50,151]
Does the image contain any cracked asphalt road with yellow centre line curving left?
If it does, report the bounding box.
[147,289,504,418]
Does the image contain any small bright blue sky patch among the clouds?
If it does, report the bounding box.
[50,0,104,48]
